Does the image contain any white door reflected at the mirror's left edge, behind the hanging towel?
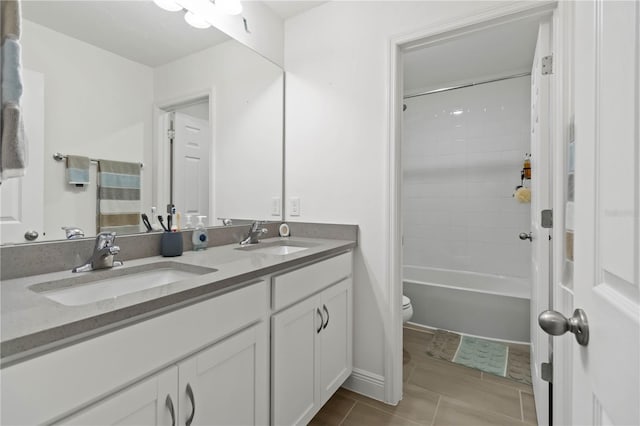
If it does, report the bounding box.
[0,69,44,244]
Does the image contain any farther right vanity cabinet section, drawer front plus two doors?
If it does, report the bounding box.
[271,253,353,425]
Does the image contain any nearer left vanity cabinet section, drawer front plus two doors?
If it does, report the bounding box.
[0,281,269,426]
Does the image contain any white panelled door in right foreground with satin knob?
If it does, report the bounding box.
[561,0,640,425]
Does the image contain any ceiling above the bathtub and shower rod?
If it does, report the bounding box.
[403,19,539,94]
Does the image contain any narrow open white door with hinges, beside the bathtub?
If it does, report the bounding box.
[530,18,553,425]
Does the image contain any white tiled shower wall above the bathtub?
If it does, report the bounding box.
[402,77,531,278]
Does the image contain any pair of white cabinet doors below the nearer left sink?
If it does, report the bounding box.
[60,323,269,426]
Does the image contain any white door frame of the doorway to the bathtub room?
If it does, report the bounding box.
[384,1,563,405]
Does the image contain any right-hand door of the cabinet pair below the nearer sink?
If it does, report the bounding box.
[178,322,269,426]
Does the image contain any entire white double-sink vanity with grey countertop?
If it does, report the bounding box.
[0,225,356,425]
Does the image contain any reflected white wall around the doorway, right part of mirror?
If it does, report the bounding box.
[154,41,283,225]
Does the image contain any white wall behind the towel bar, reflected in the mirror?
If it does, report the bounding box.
[21,20,153,239]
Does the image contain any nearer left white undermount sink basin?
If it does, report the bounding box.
[29,262,216,306]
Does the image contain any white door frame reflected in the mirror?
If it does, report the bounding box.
[151,87,216,220]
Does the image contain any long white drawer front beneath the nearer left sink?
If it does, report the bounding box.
[0,281,268,425]
